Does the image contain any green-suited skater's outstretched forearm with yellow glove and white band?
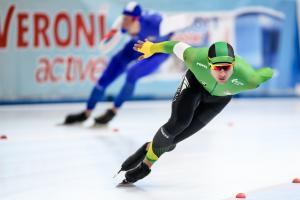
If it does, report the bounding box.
[134,41,191,61]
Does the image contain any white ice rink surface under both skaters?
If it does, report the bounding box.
[0,98,300,200]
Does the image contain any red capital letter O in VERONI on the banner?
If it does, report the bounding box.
[53,13,72,47]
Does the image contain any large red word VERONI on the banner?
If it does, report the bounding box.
[0,4,108,48]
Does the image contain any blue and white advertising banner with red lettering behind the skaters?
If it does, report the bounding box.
[0,0,300,102]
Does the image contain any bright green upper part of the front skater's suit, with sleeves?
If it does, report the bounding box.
[144,41,273,96]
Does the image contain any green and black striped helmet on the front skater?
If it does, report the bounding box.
[208,42,235,64]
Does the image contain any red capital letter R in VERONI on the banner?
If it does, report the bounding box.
[33,13,50,48]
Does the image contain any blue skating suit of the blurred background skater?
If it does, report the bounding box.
[87,12,173,110]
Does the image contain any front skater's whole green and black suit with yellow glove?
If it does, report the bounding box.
[139,41,273,163]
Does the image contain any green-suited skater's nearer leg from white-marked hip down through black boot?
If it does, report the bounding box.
[125,71,202,183]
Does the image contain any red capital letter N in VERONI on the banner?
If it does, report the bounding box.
[75,13,95,47]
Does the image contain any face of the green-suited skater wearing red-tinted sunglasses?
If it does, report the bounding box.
[210,63,233,84]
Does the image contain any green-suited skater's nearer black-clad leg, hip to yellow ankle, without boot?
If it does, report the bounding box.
[145,71,204,166]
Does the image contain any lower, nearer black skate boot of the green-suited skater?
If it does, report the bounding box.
[125,162,151,183]
